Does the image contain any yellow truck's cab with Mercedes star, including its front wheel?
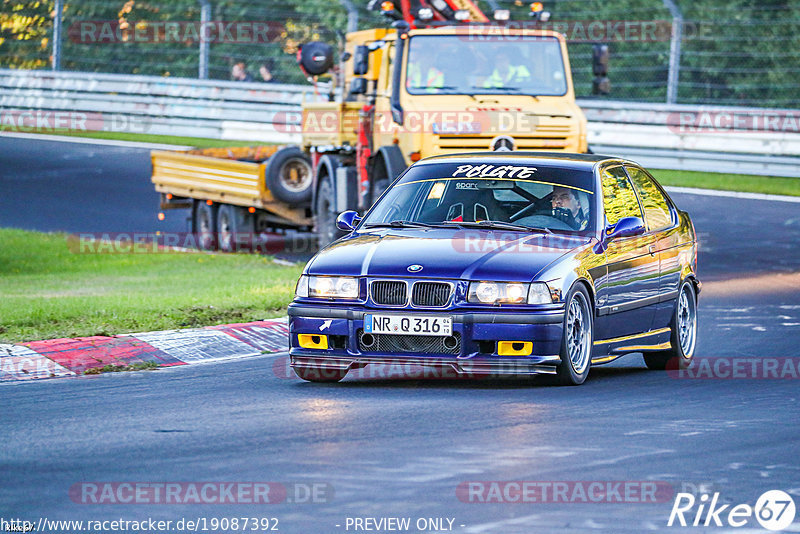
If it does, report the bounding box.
[302,24,587,243]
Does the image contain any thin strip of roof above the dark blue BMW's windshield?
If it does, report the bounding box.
[416,150,633,171]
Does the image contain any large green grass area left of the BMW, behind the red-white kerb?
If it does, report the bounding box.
[0,229,302,343]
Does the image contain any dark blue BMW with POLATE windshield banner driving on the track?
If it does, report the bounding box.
[289,152,700,385]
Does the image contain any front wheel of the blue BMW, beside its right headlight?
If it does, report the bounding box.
[554,284,594,386]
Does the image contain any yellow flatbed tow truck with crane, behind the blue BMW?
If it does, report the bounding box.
[153,0,587,250]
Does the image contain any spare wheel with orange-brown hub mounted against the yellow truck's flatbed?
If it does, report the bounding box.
[265,146,313,204]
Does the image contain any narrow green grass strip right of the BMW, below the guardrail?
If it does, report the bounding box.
[648,169,800,196]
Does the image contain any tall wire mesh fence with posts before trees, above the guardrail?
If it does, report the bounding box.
[0,0,800,108]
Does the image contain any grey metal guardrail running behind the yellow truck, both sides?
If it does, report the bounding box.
[0,69,800,177]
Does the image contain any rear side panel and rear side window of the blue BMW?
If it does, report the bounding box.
[625,165,682,329]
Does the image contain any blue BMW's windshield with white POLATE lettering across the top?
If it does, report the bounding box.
[361,164,595,235]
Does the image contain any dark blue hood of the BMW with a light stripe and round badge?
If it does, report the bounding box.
[306,229,590,282]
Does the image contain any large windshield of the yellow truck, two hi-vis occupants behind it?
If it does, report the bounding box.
[406,35,567,96]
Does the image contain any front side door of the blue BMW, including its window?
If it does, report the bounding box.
[595,165,659,340]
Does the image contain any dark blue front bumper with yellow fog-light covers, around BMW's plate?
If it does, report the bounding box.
[288,303,564,376]
